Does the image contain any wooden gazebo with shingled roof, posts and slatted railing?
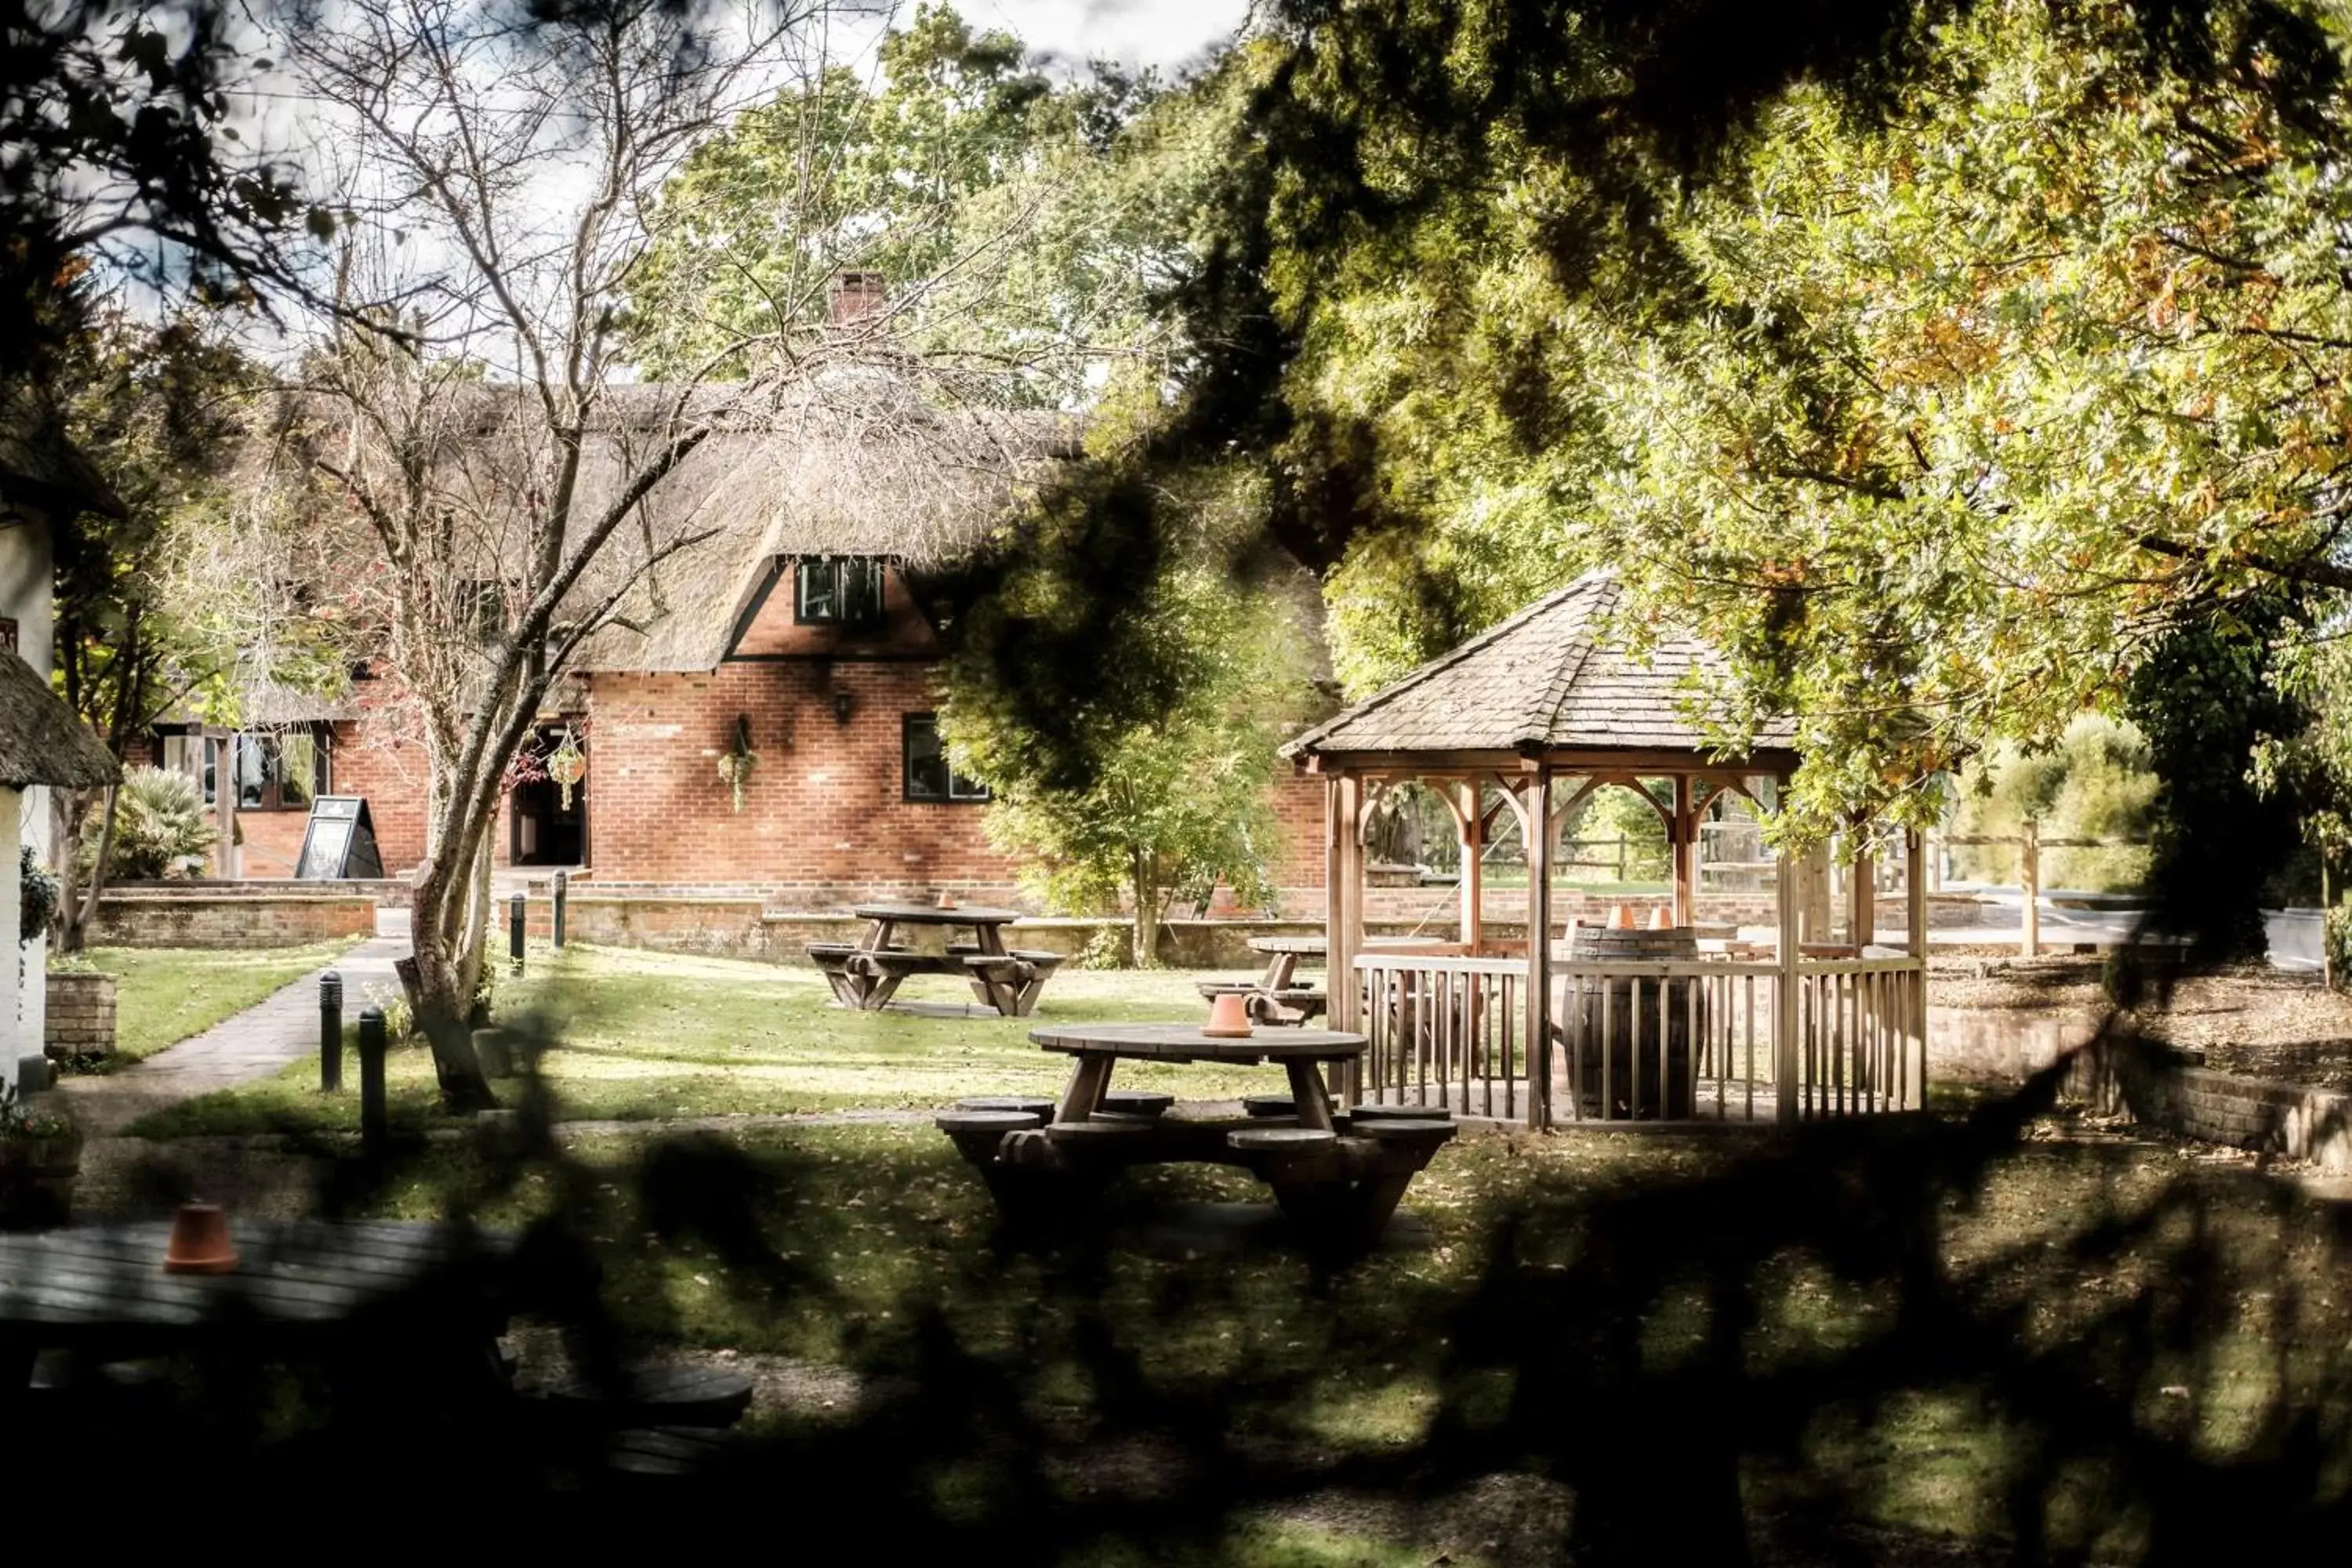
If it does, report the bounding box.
[1282,572,1926,1126]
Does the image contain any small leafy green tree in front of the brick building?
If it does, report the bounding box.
[941,460,1305,966]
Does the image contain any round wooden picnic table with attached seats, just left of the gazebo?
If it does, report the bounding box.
[934,1025,1456,1250]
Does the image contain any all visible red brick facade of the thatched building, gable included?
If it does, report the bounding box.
[289,567,1324,914]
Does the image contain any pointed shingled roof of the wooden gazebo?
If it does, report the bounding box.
[1282,572,1795,757]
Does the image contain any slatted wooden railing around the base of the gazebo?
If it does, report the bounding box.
[1355,949,1926,1123]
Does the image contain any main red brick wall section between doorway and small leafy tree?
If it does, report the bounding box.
[588,662,1014,905]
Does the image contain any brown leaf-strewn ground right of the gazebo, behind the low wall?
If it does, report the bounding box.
[1929,959,2352,1088]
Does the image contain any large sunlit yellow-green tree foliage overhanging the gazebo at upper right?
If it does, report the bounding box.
[1214,0,2352,860]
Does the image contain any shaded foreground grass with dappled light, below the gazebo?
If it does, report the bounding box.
[156,1109,2352,1563]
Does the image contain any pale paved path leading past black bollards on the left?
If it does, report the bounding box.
[59,926,409,1138]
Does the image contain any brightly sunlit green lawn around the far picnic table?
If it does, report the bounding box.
[134,945,1282,1135]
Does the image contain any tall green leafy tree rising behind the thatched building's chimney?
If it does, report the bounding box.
[628,5,1152,405]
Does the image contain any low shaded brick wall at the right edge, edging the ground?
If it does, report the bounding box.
[2067,1041,2352,1171]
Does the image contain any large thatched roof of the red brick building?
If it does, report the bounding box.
[247,383,1077,670]
